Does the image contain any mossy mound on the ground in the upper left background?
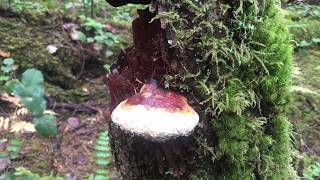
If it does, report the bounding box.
[0,11,80,88]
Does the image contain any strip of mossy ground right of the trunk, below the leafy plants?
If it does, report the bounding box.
[289,47,320,167]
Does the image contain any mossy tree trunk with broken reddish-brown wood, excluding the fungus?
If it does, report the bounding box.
[107,0,296,179]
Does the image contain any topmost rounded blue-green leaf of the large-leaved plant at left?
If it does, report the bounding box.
[22,69,44,86]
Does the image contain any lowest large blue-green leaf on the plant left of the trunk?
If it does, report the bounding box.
[34,115,58,137]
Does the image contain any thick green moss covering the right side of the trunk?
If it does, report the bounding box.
[159,0,296,179]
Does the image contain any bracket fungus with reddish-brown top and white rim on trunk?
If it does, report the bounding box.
[111,84,199,141]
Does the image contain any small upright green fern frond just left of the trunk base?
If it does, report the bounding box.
[89,131,112,180]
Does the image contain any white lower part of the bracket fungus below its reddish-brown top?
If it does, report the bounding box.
[111,84,199,141]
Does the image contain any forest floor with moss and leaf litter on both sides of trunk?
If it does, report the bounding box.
[0,1,320,179]
